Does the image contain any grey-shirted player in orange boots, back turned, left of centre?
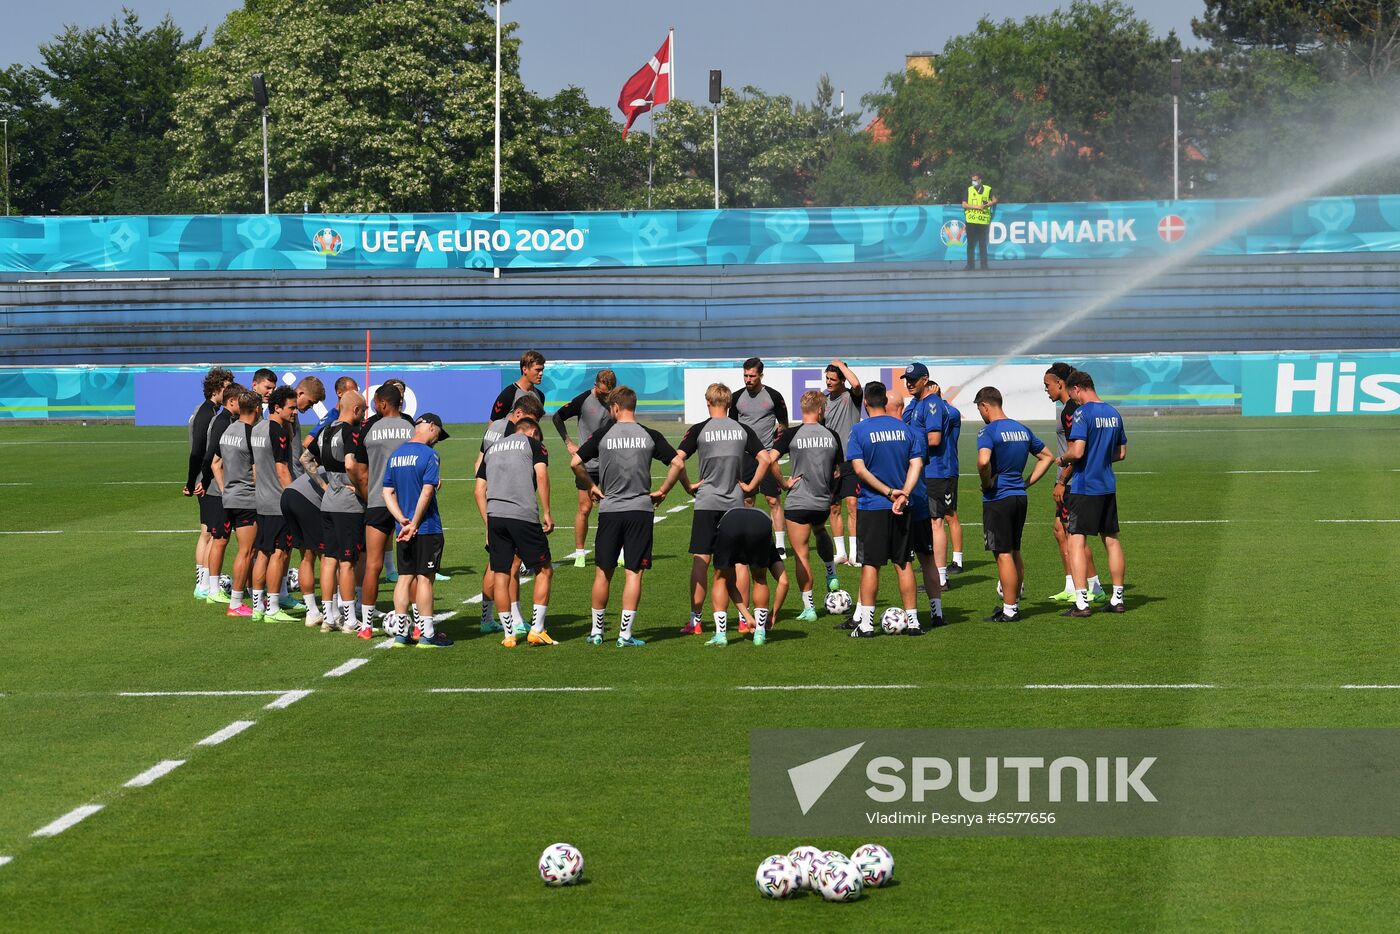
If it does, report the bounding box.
[476,419,556,648]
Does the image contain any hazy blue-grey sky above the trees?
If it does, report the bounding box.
[0,0,1204,109]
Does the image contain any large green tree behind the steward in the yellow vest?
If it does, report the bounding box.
[867,0,1182,203]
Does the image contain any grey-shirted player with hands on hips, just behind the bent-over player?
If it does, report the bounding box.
[666,382,763,636]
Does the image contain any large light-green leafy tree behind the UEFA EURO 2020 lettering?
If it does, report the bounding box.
[171,0,540,211]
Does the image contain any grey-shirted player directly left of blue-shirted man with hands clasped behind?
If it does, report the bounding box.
[764,389,846,623]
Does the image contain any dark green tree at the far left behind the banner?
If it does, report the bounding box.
[0,10,202,214]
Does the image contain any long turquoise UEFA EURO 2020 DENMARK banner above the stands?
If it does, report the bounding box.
[0,196,1400,274]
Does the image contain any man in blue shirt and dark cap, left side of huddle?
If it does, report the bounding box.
[384,412,452,648]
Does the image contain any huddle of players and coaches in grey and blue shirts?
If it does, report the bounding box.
[185,350,1127,647]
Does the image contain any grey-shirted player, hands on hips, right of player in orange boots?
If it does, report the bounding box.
[570,386,676,647]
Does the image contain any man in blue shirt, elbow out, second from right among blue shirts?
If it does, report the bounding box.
[974,386,1054,623]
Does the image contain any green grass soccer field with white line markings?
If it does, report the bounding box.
[0,413,1400,931]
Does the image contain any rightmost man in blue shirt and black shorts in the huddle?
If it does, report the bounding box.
[1061,370,1128,618]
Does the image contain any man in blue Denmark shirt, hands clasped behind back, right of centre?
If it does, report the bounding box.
[846,381,927,639]
